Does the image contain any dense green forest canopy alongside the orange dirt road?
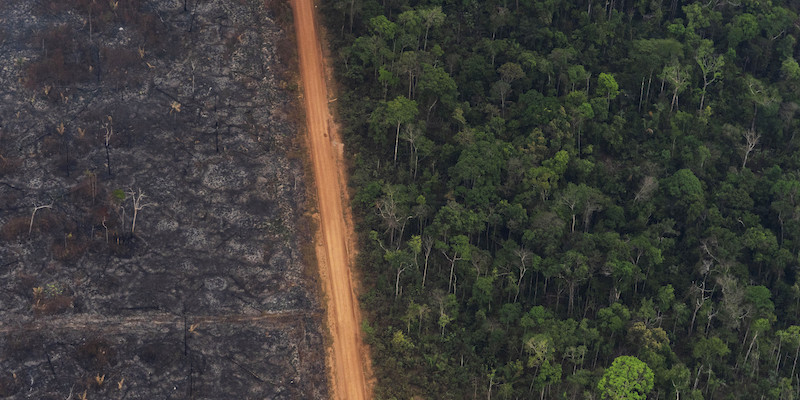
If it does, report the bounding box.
[321,0,800,399]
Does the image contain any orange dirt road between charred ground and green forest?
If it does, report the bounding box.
[292,0,371,400]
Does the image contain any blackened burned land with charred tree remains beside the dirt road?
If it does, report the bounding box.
[0,0,328,399]
